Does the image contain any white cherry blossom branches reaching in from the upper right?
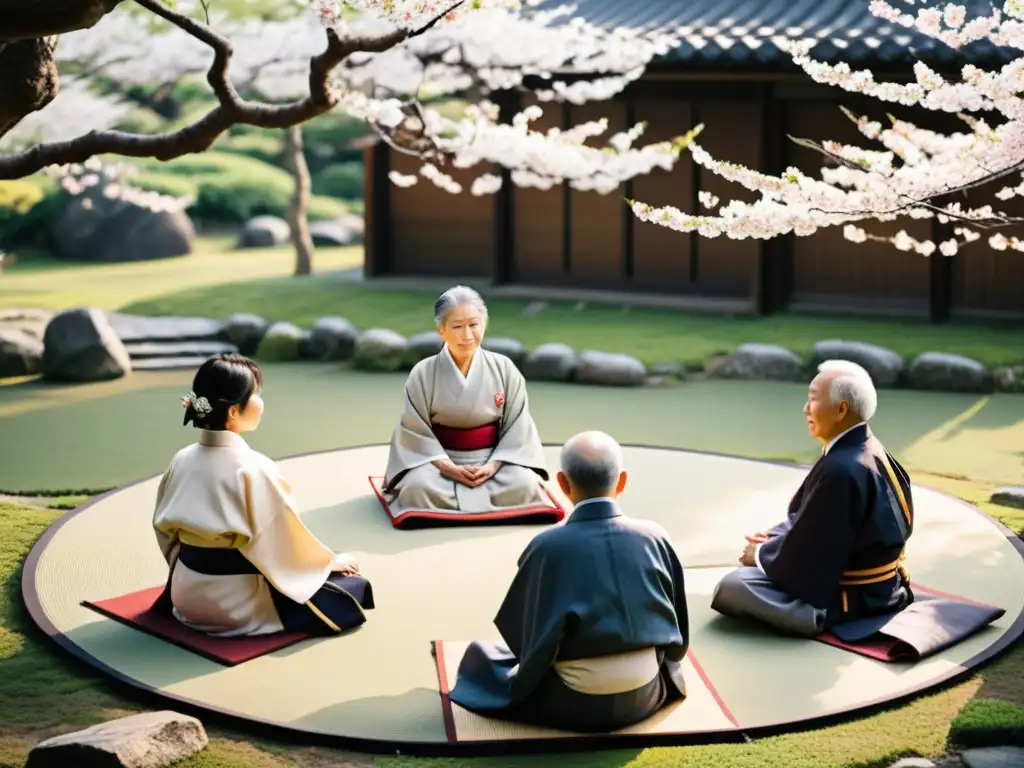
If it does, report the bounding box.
[631,0,1024,256]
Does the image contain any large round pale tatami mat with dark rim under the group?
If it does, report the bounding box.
[23,445,1024,754]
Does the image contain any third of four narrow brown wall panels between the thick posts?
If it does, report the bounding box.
[631,100,695,293]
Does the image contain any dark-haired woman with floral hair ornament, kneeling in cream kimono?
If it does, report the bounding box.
[153,355,374,637]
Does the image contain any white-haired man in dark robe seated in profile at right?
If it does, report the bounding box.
[712,360,914,637]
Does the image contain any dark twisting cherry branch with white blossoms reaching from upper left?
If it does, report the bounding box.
[0,0,692,207]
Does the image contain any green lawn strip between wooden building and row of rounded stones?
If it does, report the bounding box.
[123,275,1024,366]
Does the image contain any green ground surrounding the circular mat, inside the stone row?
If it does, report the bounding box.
[0,364,1024,768]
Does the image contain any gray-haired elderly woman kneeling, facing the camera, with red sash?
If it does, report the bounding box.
[382,286,557,521]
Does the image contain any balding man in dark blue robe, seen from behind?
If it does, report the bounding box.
[451,432,689,732]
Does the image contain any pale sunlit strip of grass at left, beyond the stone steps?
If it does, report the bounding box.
[0,240,362,314]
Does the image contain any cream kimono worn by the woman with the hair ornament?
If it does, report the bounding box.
[153,430,335,637]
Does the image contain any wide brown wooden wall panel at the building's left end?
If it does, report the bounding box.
[391,151,494,278]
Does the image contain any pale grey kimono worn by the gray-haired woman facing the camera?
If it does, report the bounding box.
[384,346,551,517]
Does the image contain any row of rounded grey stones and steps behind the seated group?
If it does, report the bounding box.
[0,309,1024,394]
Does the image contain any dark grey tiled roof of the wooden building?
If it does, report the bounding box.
[541,0,1019,70]
